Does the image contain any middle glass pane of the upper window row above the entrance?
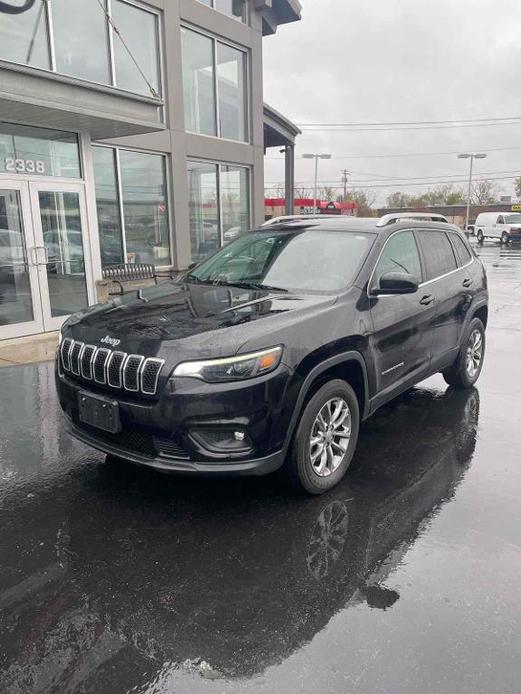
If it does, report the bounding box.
[52,0,110,84]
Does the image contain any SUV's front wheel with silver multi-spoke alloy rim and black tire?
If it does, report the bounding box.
[285,379,360,494]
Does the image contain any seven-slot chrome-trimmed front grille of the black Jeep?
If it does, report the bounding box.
[60,337,165,395]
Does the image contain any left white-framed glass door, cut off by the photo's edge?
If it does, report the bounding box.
[0,179,43,339]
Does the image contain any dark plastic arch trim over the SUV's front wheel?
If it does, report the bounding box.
[284,351,369,451]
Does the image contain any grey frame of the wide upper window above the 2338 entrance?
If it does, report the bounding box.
[0,0,164,98]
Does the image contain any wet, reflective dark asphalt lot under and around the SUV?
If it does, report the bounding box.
[0,242,521,694]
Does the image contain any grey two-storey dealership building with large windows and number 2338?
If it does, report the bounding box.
[0,0,300,339]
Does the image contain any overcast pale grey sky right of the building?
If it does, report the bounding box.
[264,0,521,204]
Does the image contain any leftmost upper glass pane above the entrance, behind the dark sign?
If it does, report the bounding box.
[0,0,51,70]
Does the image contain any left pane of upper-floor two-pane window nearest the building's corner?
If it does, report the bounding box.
[181,29,217,135]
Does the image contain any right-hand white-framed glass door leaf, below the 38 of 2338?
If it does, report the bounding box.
[29,183,94,330]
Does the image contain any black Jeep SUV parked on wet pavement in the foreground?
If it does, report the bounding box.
[56,215,488,494]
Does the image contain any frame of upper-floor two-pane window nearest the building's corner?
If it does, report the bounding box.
[181,24,252,144]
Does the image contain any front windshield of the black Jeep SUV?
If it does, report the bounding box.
[186,229,374,292]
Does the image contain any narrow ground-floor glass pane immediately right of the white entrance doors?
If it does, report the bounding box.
[92,147,124,266]
